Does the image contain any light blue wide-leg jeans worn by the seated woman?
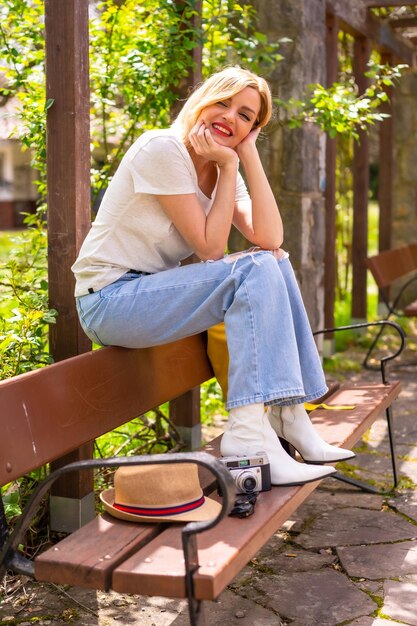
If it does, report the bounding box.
[77,250,327,409]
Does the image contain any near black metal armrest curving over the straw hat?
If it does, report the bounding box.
[0,452,236,626]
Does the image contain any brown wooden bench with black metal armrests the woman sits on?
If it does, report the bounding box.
[0,322,404,625]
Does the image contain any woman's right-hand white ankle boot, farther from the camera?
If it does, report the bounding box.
[267,404,355,464]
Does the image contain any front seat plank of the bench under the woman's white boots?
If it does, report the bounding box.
[36,382,400,600]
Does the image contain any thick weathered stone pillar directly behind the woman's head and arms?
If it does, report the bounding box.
[255,0,326,328]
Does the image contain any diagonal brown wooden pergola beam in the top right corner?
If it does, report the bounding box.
[327,0,415,65]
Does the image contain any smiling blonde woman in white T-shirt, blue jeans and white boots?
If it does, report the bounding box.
[73,67,354,485]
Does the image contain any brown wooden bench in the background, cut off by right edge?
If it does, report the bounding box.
[364,243,417,367]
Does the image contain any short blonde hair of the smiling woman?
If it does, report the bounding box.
[174,66,272,143]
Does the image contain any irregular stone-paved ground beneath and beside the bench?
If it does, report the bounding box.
[0,344,417,626]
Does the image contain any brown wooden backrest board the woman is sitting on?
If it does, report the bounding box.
[0,335,213,485]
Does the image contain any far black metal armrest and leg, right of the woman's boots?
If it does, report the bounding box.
[313,320,406,495]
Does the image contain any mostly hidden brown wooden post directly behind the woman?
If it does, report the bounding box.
[169,0,202,450]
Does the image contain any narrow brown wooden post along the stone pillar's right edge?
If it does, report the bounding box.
[323,14,339,355]
